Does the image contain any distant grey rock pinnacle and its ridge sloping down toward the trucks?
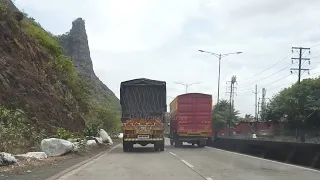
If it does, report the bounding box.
[59,18,120,110]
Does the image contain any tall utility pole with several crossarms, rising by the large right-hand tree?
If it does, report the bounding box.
[290,47,310,142]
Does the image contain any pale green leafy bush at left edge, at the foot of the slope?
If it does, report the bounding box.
[0,106,45,154]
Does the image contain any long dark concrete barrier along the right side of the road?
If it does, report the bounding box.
[210,138,320,169]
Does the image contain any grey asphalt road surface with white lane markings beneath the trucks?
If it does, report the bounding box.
[53,140,320,180]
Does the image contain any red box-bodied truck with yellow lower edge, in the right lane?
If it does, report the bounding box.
[170,93,212,147]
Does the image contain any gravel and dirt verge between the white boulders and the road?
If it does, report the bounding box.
[0,139,121,180]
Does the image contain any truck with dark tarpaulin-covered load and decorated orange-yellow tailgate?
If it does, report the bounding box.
[120,78,167,152]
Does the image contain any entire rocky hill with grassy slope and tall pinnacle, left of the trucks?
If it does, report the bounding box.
[0,0,120,152]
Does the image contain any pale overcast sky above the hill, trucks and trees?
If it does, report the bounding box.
[15,0,320,115]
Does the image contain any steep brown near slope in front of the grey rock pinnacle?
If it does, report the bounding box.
[0,0,85,133]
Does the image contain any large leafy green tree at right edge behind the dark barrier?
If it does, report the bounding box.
[266,78,320,142]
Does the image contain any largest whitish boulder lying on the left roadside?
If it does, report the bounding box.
[41,138,74,156]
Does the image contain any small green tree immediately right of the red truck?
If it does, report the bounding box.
[213,100,240,130]
